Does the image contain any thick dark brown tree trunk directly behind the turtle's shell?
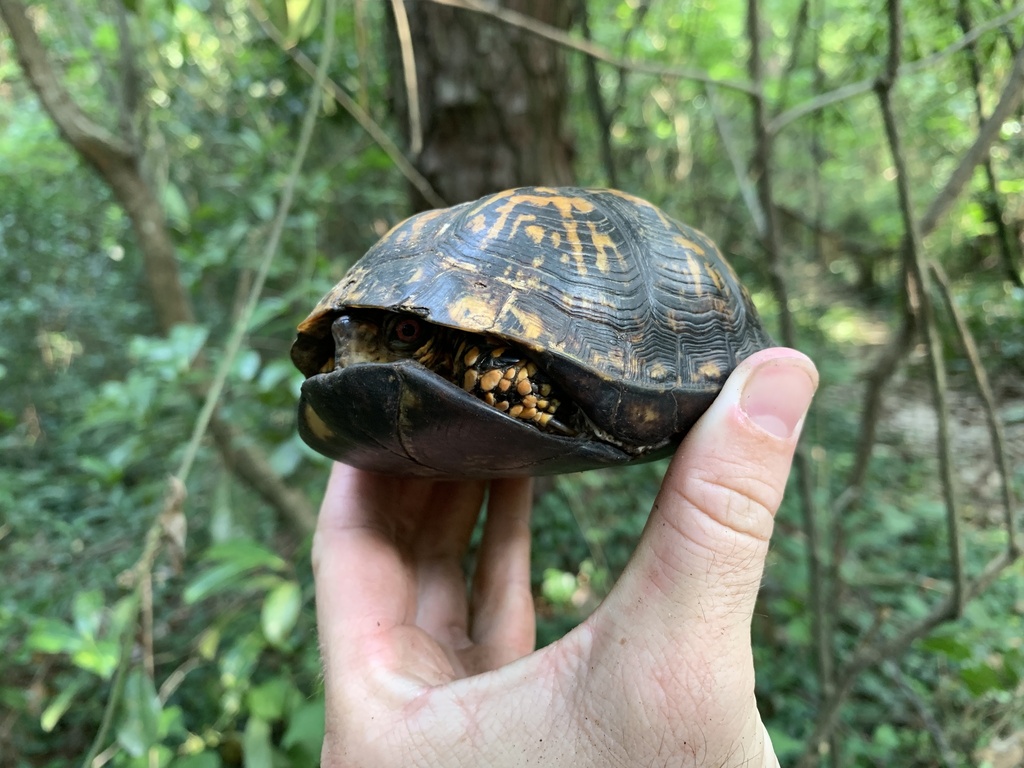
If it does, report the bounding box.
[389,0,573,211]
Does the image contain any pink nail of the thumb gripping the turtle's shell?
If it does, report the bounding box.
[740,357,817,439]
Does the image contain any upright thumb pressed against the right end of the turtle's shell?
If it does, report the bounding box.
[595,348,818,653]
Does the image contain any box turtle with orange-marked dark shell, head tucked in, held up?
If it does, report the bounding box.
[291,186,772,478]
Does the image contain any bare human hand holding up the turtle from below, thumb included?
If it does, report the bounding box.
[313,348,818,768]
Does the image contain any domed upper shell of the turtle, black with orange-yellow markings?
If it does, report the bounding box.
[293,187,771,450]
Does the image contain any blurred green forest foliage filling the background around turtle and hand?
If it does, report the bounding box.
[0,0,1024,768]
